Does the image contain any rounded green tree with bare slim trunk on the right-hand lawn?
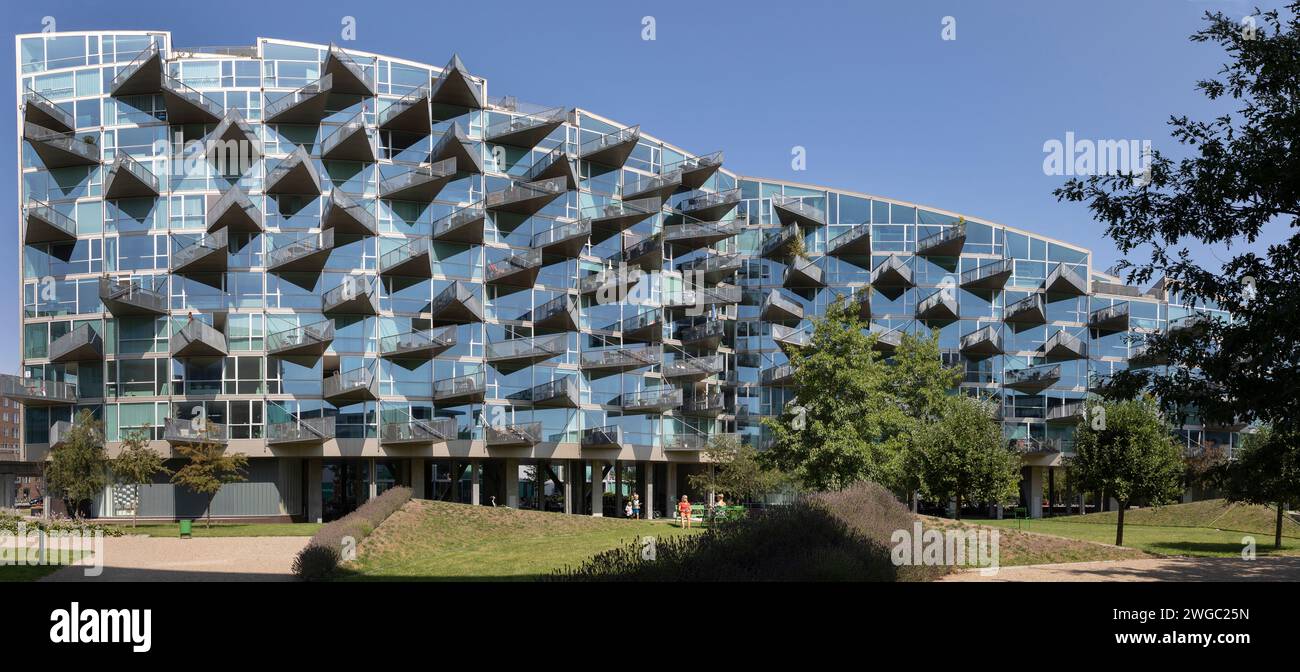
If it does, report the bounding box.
[1067,396,1186,546]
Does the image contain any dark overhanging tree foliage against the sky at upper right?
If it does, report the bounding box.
[1056,1,1300,435]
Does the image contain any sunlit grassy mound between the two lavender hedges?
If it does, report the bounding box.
[339,499,696,581]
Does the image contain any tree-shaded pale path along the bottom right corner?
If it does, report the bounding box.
[941,556,1300,582]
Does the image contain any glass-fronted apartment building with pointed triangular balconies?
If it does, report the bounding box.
[3,31,1234,520]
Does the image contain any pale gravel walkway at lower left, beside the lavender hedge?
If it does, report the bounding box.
[42,537,308,581]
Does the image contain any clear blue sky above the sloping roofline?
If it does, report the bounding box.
[0,0,1282,372]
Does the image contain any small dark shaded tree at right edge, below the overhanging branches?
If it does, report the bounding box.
[1216,426,1300,549]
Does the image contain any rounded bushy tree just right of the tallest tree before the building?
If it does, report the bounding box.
[906,395,1021,520]
